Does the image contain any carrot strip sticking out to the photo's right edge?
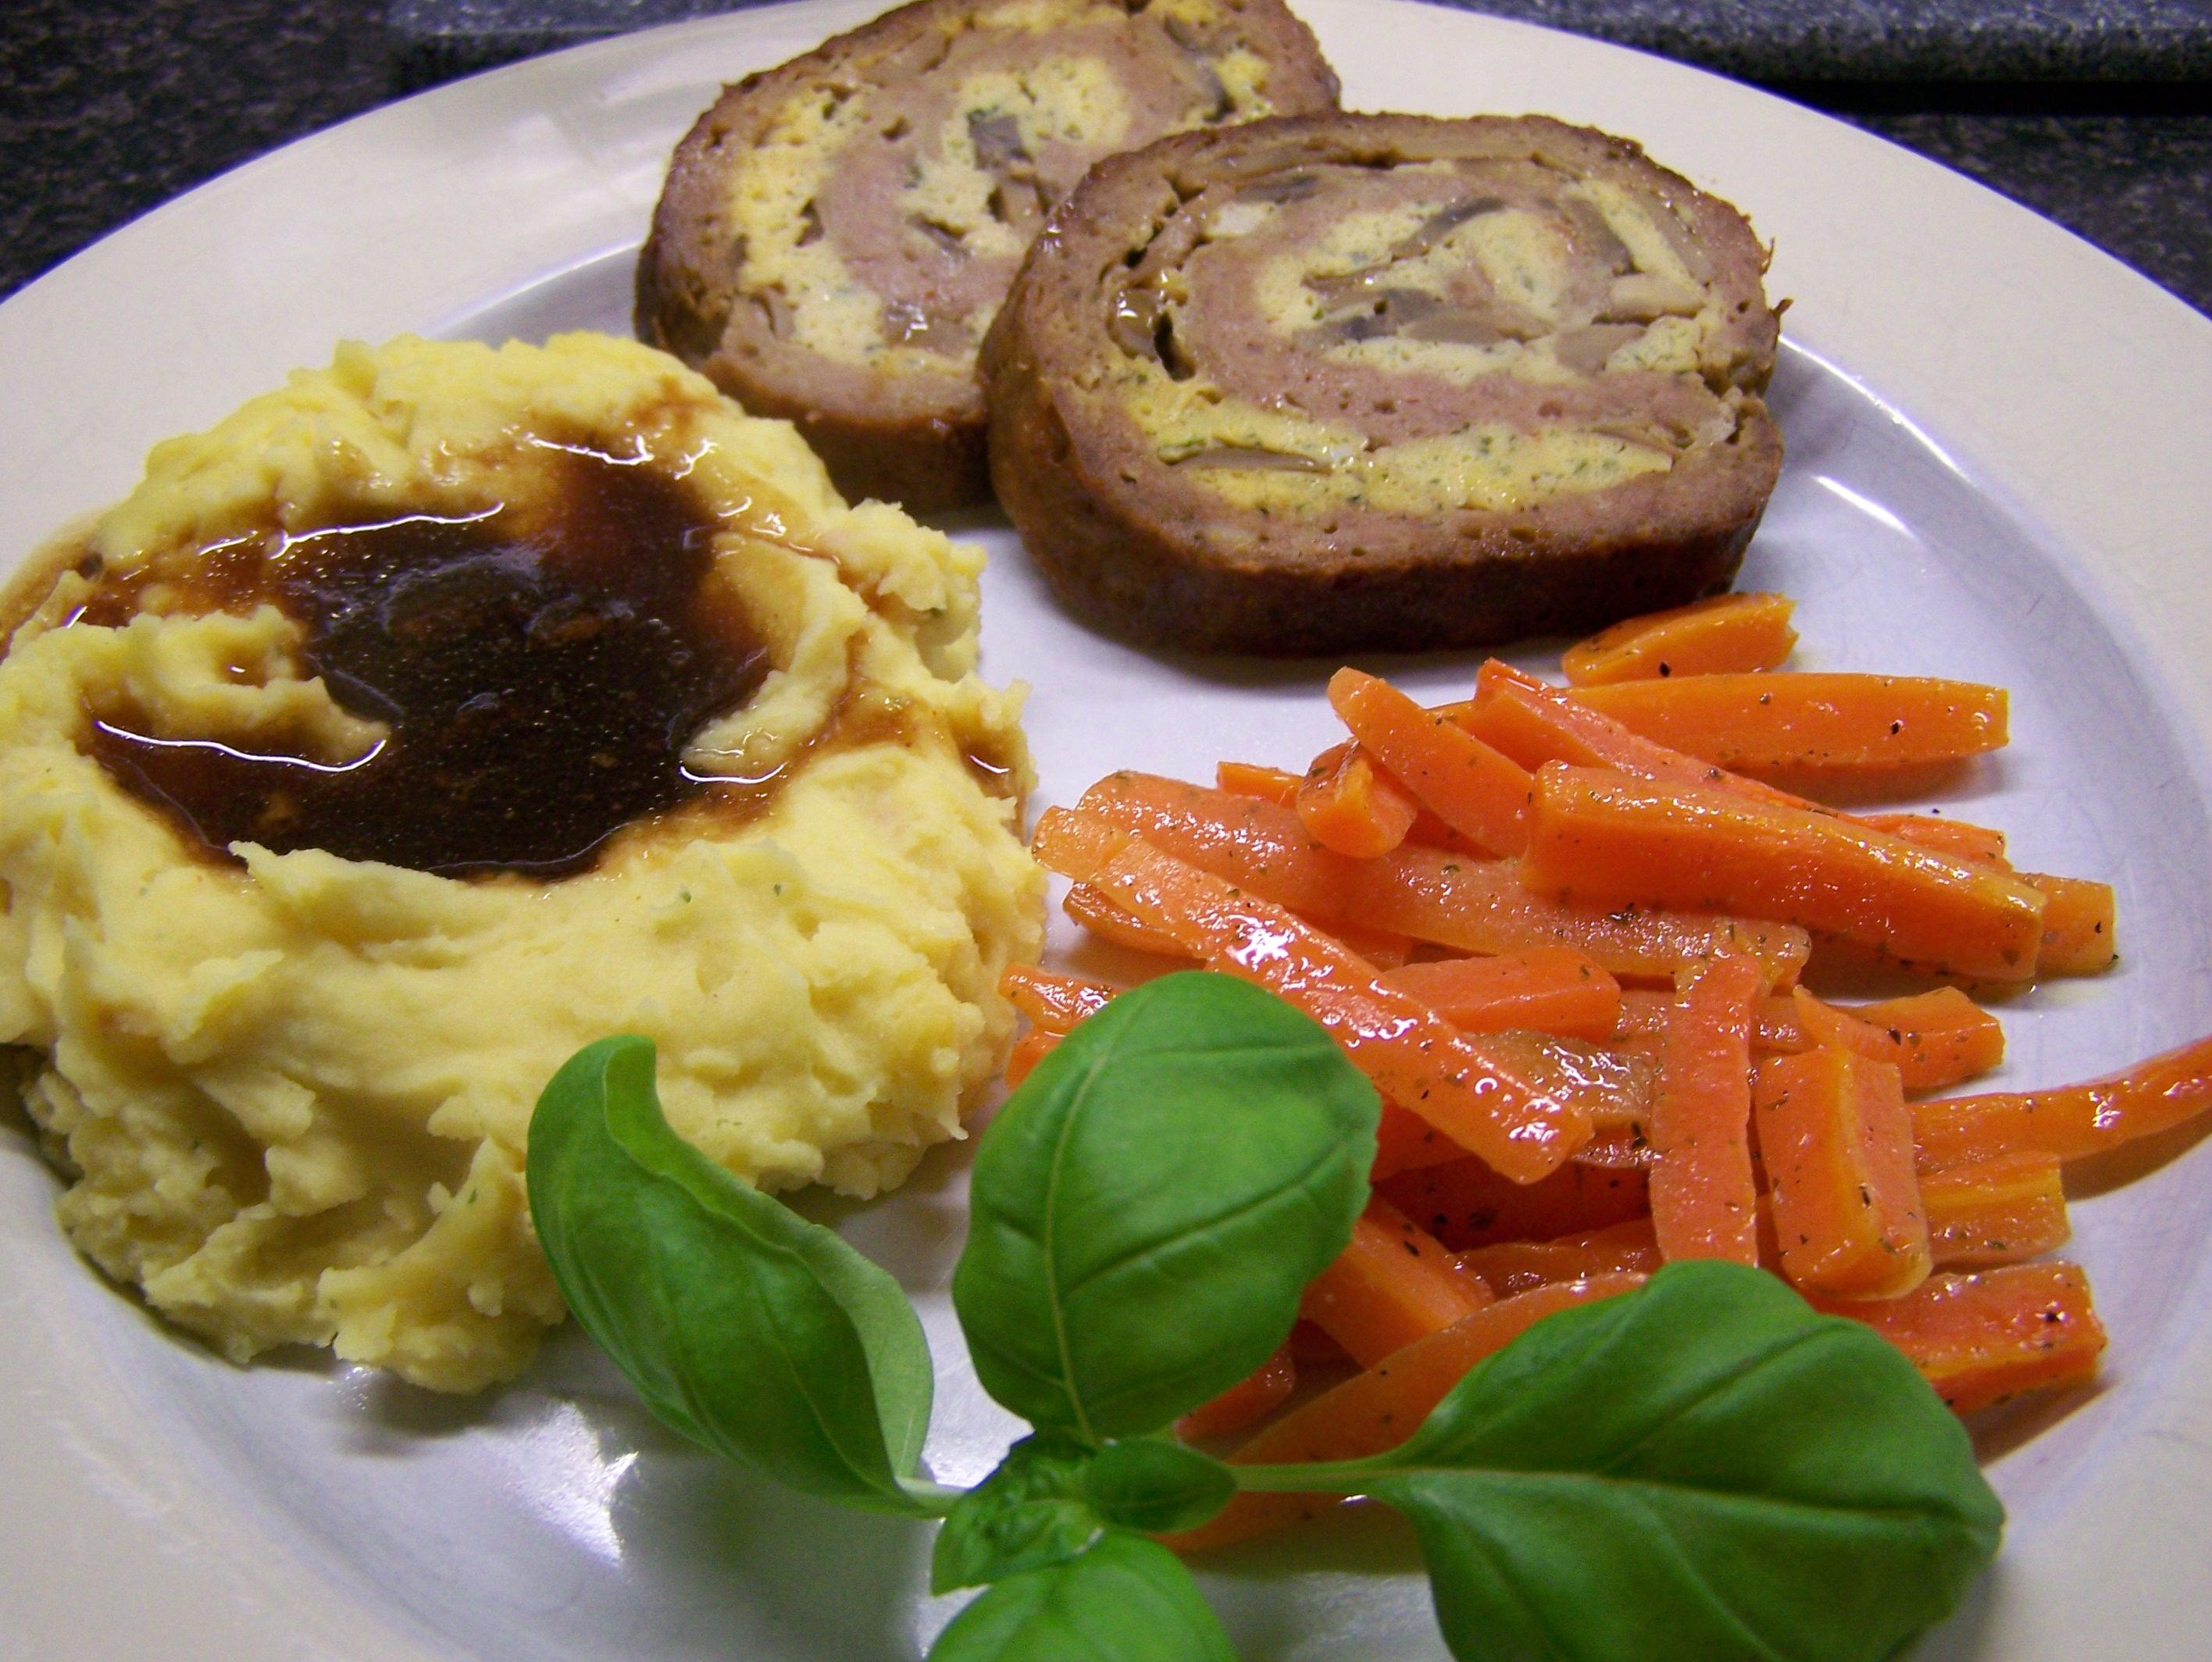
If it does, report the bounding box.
[1914,1038,2212,1166]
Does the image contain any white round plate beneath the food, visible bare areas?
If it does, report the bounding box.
[0,0,2212,1662]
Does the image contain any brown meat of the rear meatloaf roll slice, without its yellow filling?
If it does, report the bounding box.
[635,0,1336,512]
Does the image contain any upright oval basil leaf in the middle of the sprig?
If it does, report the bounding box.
[954,972,1380,1443]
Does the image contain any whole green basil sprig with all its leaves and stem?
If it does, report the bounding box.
[529,974,2004,1662]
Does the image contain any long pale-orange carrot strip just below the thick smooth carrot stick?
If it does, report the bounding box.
[1082,772,1807,985]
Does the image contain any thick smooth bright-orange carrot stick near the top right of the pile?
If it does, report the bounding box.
[1526,764,2044,980]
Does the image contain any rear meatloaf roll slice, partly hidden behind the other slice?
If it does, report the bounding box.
[637,0,1336,509]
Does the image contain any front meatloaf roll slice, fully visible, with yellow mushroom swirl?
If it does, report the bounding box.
[982,115,1783,655]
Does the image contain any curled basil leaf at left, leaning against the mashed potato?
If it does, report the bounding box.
[524,1038,942,1514]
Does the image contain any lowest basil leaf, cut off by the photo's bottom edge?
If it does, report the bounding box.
[929,1531,1236,1662]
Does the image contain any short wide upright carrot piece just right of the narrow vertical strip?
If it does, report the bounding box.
[1751,1047,1931,1299]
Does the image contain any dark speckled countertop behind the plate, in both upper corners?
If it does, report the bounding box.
[0,0,2212,310]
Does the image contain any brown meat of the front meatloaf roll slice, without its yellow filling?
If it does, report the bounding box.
[982,115,1781,655]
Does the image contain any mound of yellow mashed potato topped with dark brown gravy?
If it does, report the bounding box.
[0,334,1044,1389]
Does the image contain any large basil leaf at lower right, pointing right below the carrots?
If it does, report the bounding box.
[1340,1264,2004,1662]
